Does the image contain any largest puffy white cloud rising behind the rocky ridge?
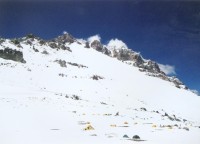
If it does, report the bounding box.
[107,38,128,49]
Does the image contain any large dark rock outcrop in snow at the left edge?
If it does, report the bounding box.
[0,48,26,63]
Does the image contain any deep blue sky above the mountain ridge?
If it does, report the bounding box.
[0,0,200,91]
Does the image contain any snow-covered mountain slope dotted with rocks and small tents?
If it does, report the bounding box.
[0,34,200,144]
